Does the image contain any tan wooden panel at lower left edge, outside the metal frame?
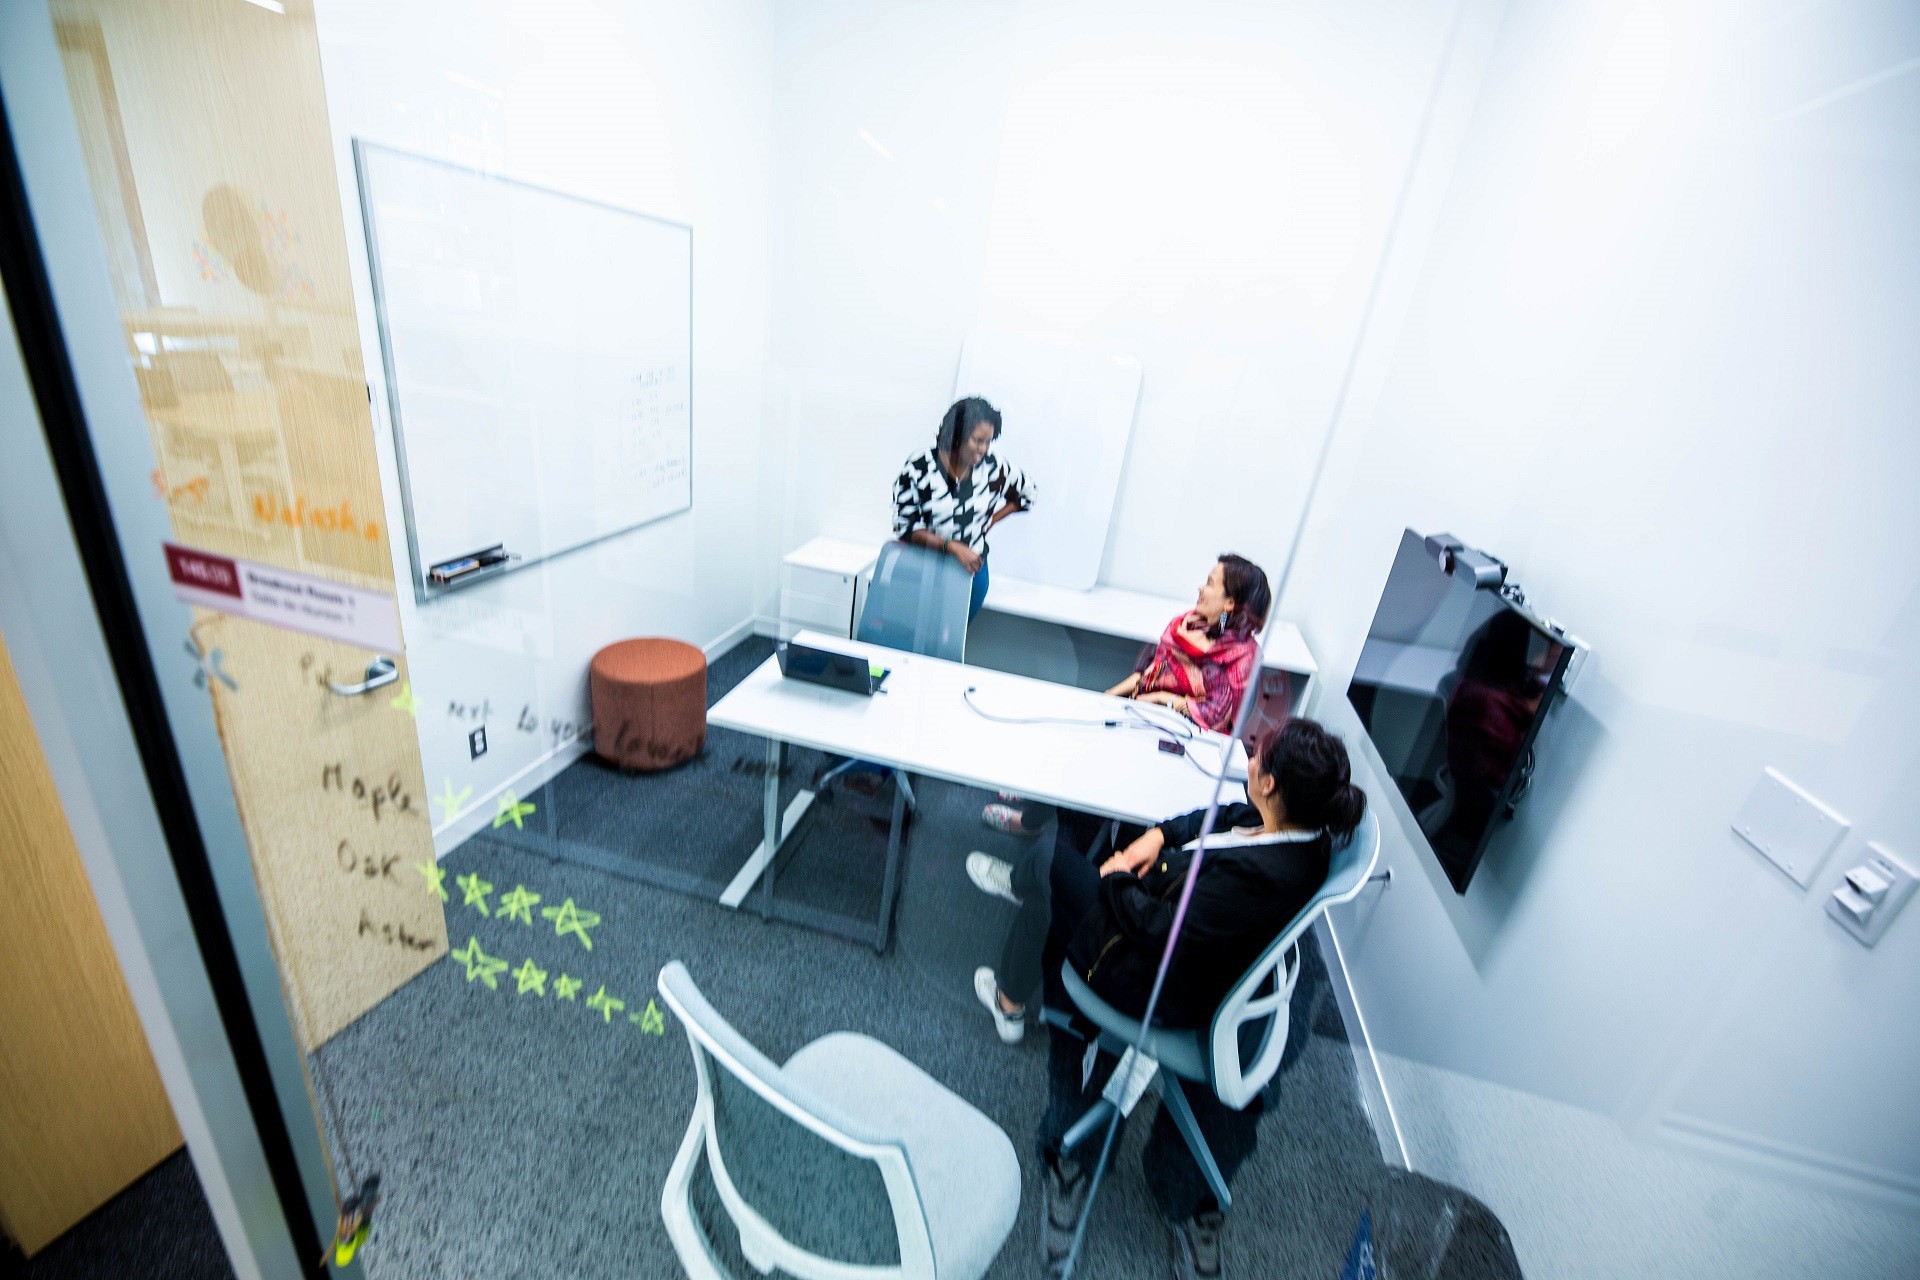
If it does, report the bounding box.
[0,645,180,1255]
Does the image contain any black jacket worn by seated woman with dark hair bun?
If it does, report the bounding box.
[1068,804,1332,1027]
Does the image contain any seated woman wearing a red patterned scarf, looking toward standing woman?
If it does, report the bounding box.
[981,553,1273,836]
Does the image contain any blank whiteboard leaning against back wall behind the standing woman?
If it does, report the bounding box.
[954,328,1140,591]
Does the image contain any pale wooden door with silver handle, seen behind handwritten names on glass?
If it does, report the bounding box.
[52,0,447,1048]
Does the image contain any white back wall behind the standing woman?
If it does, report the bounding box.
[766,0,1457,610]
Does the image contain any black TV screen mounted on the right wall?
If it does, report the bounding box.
[1346,530,1572,892]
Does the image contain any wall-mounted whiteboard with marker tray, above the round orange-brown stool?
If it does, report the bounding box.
[353,142,693,599]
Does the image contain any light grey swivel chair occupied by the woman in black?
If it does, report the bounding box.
[1048,806,1380,1209]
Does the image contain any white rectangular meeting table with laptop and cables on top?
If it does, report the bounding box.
[707,631,1246,950]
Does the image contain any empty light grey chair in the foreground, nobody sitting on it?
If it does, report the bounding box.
[660,960,1020,1280]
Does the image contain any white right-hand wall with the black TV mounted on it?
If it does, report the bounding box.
[1283,0,1920,1276]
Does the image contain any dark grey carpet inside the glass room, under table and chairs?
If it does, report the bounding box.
[303,641,1497,1280]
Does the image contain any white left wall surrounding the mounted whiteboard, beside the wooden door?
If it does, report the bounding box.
[317,0,774,850]
